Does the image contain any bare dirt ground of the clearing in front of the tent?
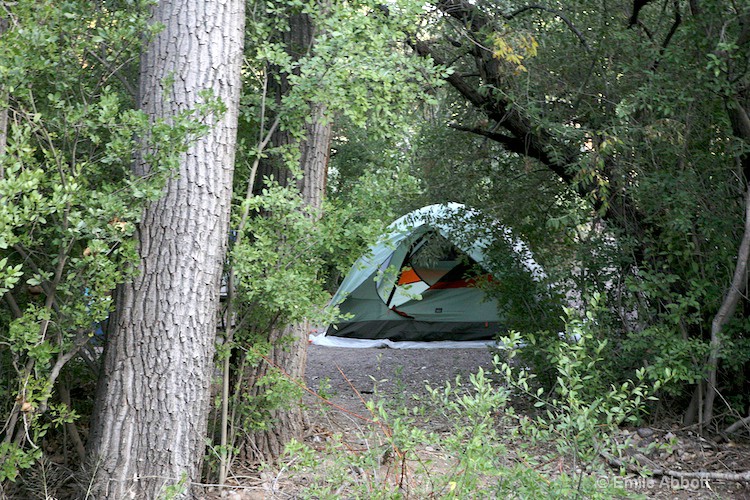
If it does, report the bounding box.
[205,345,750,500]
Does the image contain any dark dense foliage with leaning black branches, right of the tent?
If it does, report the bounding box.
[413,0,750,430]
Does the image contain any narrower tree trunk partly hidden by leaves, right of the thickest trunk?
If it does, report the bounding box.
[242,14,331,462]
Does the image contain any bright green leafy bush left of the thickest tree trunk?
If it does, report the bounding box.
[0,0,223,483]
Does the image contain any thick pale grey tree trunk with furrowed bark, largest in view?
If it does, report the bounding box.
[89,0,244,499]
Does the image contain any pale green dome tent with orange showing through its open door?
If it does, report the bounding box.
[326,203,543,341]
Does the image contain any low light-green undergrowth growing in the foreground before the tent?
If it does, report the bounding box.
[282,312,660,499]
